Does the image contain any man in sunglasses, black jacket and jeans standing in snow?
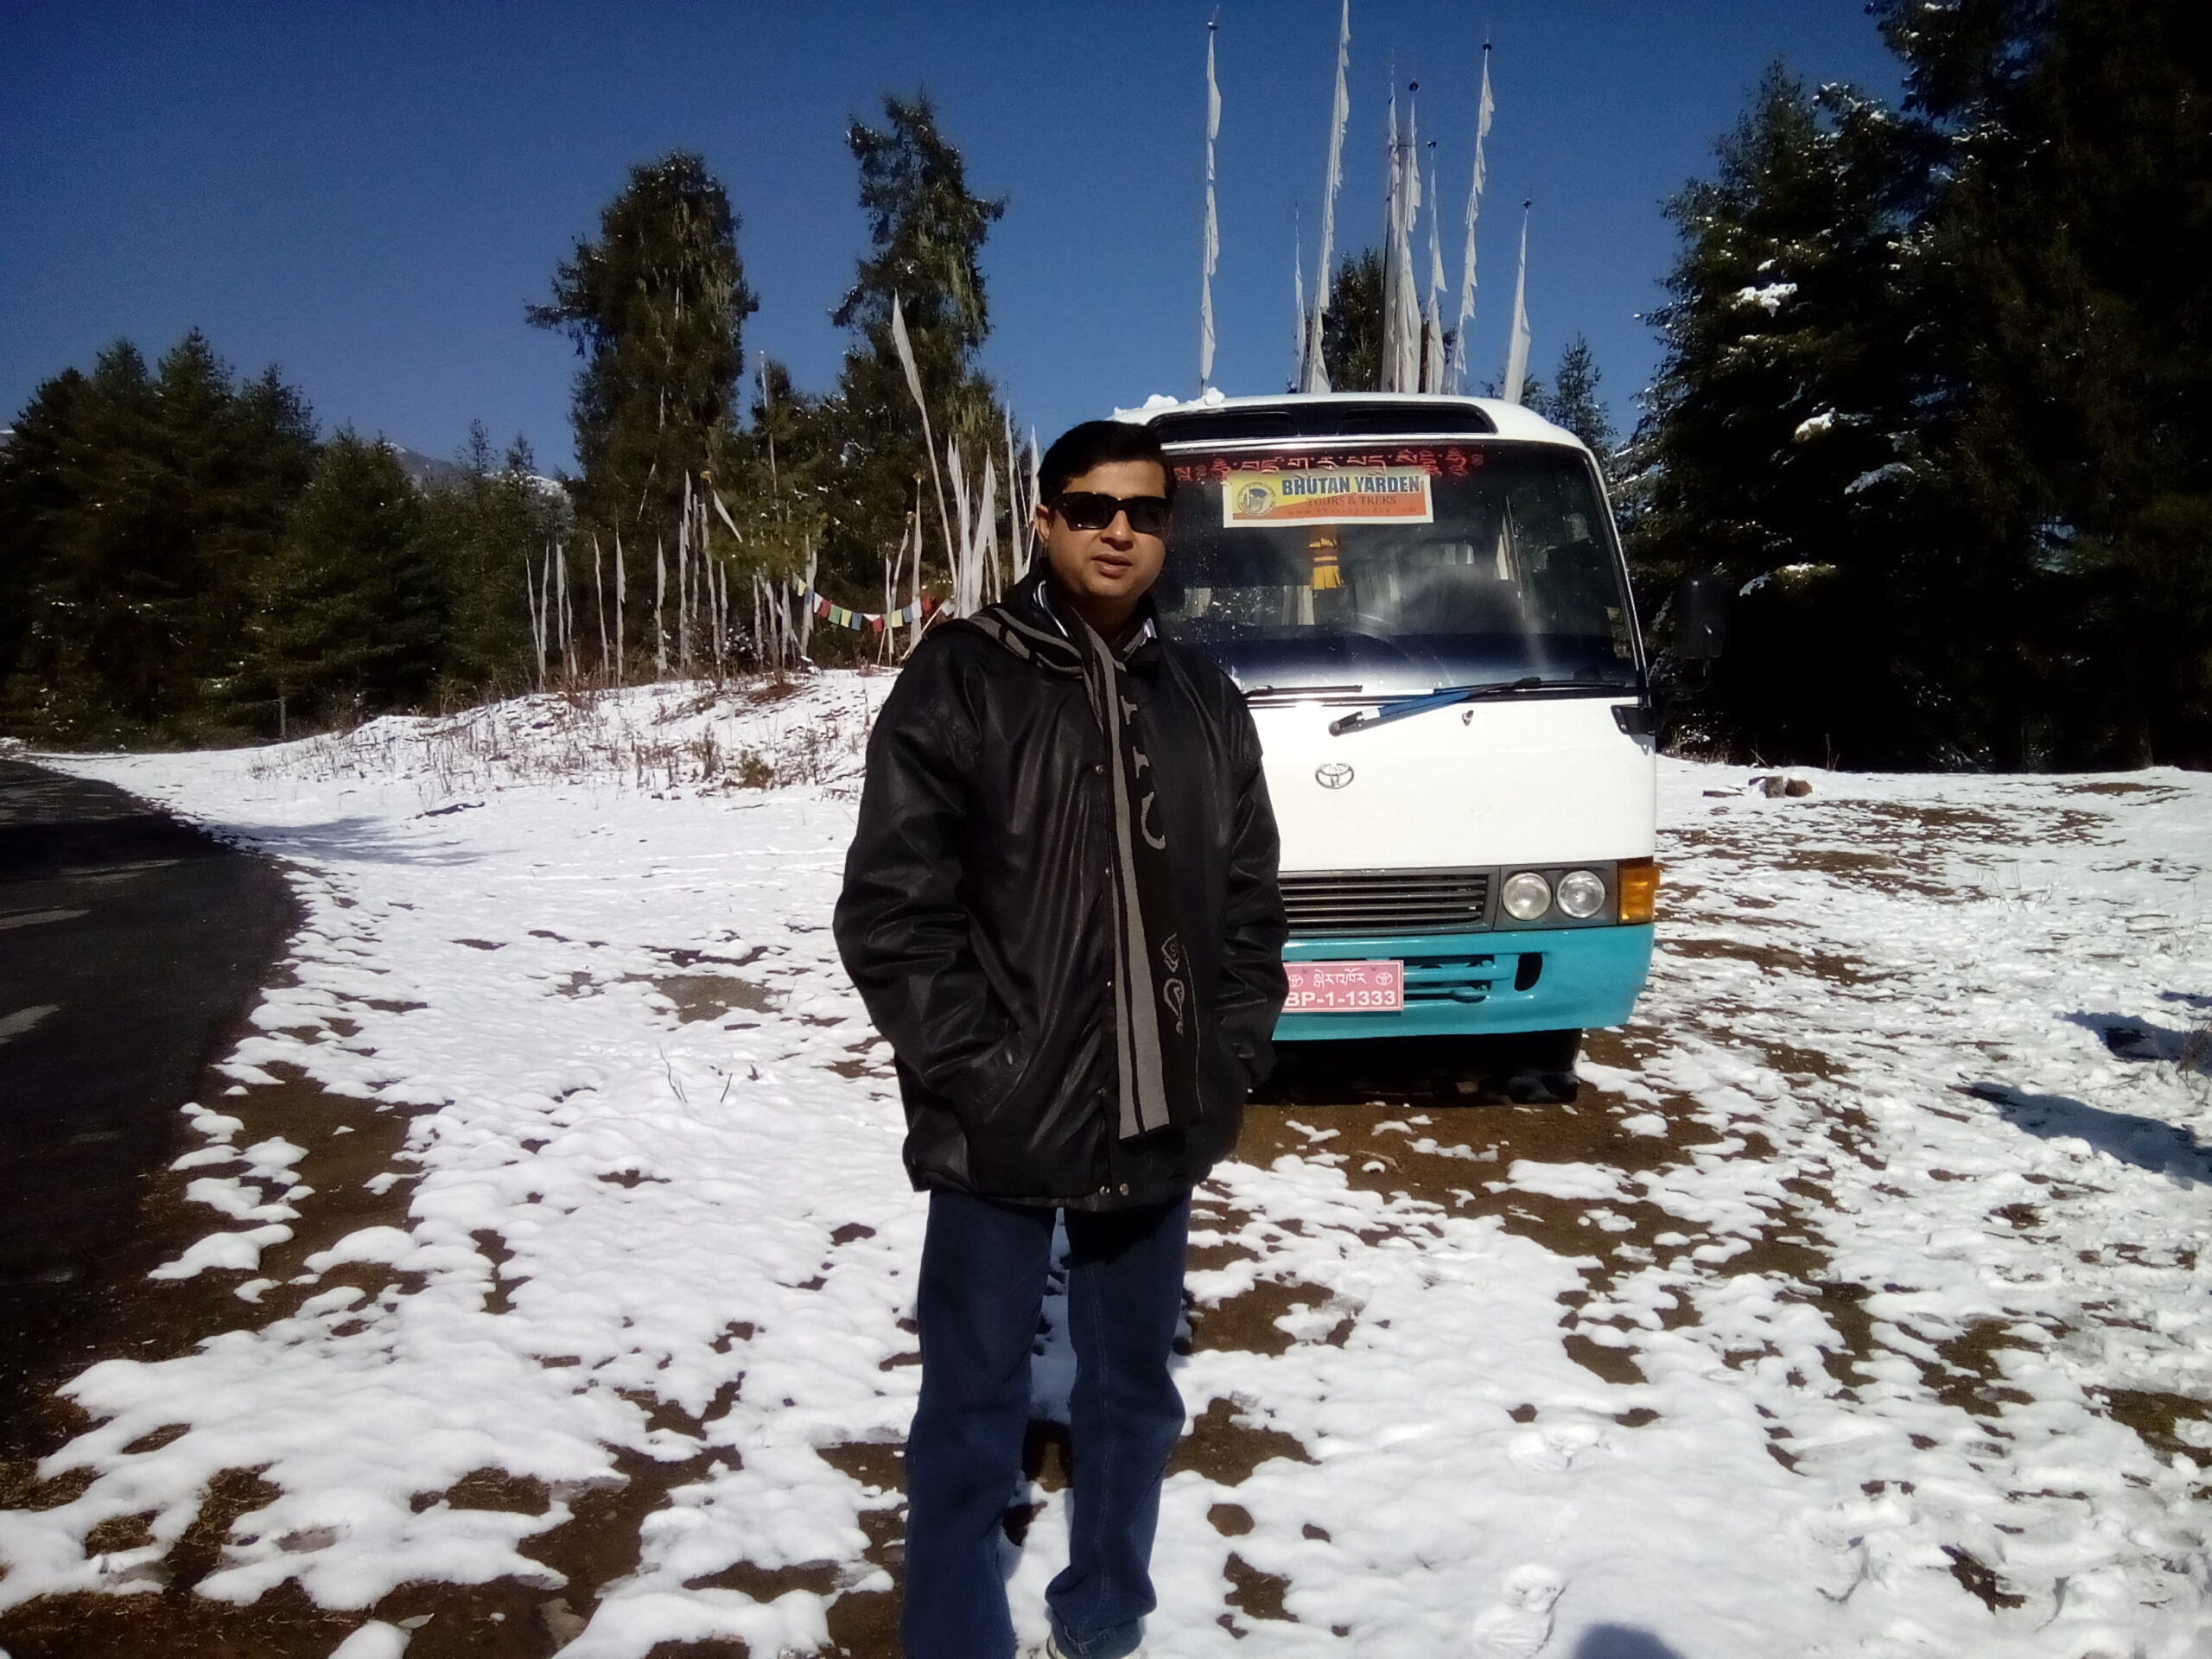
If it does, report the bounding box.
[836,420,1285,1659]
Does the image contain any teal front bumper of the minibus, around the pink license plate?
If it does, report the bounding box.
[1274,923,1652,1042]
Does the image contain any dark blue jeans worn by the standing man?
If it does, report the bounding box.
[900,1192,1190,1659]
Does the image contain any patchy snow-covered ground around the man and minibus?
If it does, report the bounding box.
[0,675,2212,1659]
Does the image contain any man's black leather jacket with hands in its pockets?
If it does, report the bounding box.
[836,593,1285,1210]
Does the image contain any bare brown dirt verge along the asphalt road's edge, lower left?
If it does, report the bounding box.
[0,1039,752,1659]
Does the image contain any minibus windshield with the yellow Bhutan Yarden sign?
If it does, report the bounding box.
[1154,442,1637,696]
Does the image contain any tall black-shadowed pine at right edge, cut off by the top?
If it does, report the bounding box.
[1876,0,2212,767]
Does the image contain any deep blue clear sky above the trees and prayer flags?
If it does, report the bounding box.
[0,0,1896,465]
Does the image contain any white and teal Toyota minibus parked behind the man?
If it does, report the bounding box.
[1123,394,1656,1092]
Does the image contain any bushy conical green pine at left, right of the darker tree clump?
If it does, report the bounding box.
[252,431,447,730]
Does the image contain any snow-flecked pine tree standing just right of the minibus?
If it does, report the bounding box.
[1628,67,1920,763]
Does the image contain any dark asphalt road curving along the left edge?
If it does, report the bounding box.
[0,761,294,1411]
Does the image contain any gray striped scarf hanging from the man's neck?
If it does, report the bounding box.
[969,562,1199,1141]
